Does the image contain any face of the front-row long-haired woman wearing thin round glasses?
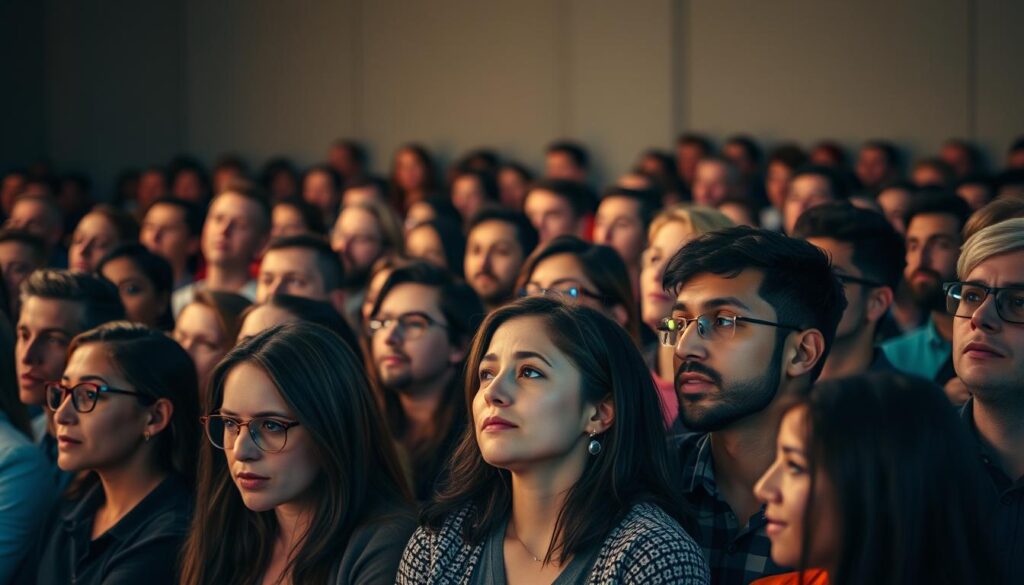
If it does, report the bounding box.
[212,363,321,512]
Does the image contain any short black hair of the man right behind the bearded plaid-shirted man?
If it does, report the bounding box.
[793,201,906,291]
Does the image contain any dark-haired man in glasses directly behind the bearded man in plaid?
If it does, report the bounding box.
[793,202,906,380]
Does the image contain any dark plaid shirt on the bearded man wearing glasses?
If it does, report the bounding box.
[673,432,784,585]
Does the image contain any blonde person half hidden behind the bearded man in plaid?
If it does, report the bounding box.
[640,205,732,434]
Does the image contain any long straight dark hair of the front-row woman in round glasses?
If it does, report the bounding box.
[181,322,409,585]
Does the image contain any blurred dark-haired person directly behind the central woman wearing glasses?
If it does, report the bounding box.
[523,179,595,244]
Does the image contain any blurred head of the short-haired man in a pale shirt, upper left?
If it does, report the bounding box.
[202,182,270,268]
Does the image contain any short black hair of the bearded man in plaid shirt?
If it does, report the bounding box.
[662,226,846,381]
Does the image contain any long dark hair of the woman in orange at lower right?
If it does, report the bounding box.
[793,374,997,585]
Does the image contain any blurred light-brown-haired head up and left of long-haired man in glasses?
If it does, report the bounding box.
[331,203,404,288]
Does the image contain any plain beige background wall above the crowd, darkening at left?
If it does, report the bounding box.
[8,0,1024,198]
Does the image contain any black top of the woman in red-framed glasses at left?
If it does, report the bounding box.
[37,475,191,585]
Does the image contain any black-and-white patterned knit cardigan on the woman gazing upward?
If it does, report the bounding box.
[396,503,711,585]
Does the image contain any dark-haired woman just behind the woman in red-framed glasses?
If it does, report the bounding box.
[96,244,174,333]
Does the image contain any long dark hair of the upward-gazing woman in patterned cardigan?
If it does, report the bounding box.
[421,297,681,562]
